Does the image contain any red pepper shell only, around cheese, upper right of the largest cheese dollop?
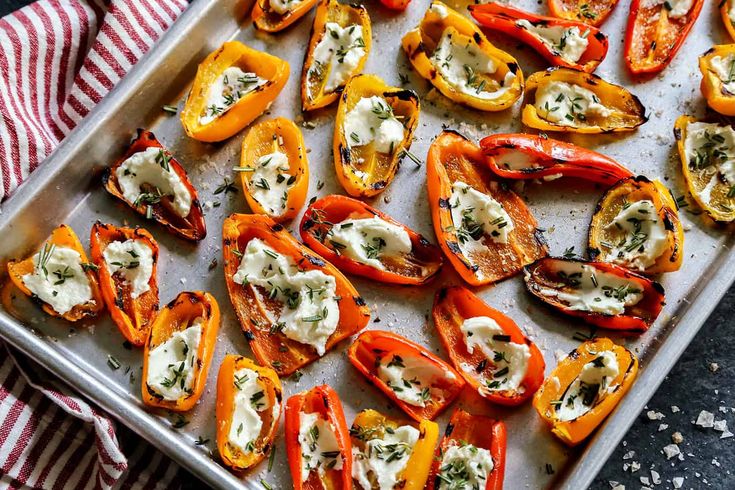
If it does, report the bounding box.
[301,195,443,285]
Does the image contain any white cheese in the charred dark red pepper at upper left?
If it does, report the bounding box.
[115,147,192,218]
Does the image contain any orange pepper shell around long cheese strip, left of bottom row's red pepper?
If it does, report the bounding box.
[216,354,283,471]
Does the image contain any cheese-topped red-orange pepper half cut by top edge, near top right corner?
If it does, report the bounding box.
[625,0,704,75]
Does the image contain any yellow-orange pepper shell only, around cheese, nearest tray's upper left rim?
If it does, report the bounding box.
[181,41,289,143]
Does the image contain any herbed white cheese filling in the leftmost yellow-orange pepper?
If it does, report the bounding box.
[21,242,94,315]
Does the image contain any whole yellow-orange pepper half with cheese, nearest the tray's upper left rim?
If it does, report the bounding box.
[181,41,289,142]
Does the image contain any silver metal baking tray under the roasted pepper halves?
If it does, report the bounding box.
[0,0,735,489]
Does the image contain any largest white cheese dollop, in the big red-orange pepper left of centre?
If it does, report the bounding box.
[232,238,339,356]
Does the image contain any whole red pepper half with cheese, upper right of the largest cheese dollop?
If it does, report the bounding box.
[301,195,443,285]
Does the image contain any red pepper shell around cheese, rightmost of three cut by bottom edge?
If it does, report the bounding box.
[426,408,508,490]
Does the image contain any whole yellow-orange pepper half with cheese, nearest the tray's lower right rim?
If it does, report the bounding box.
[533,338,638,446]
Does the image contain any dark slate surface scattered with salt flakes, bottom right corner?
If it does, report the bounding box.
[0,0,735,490]
